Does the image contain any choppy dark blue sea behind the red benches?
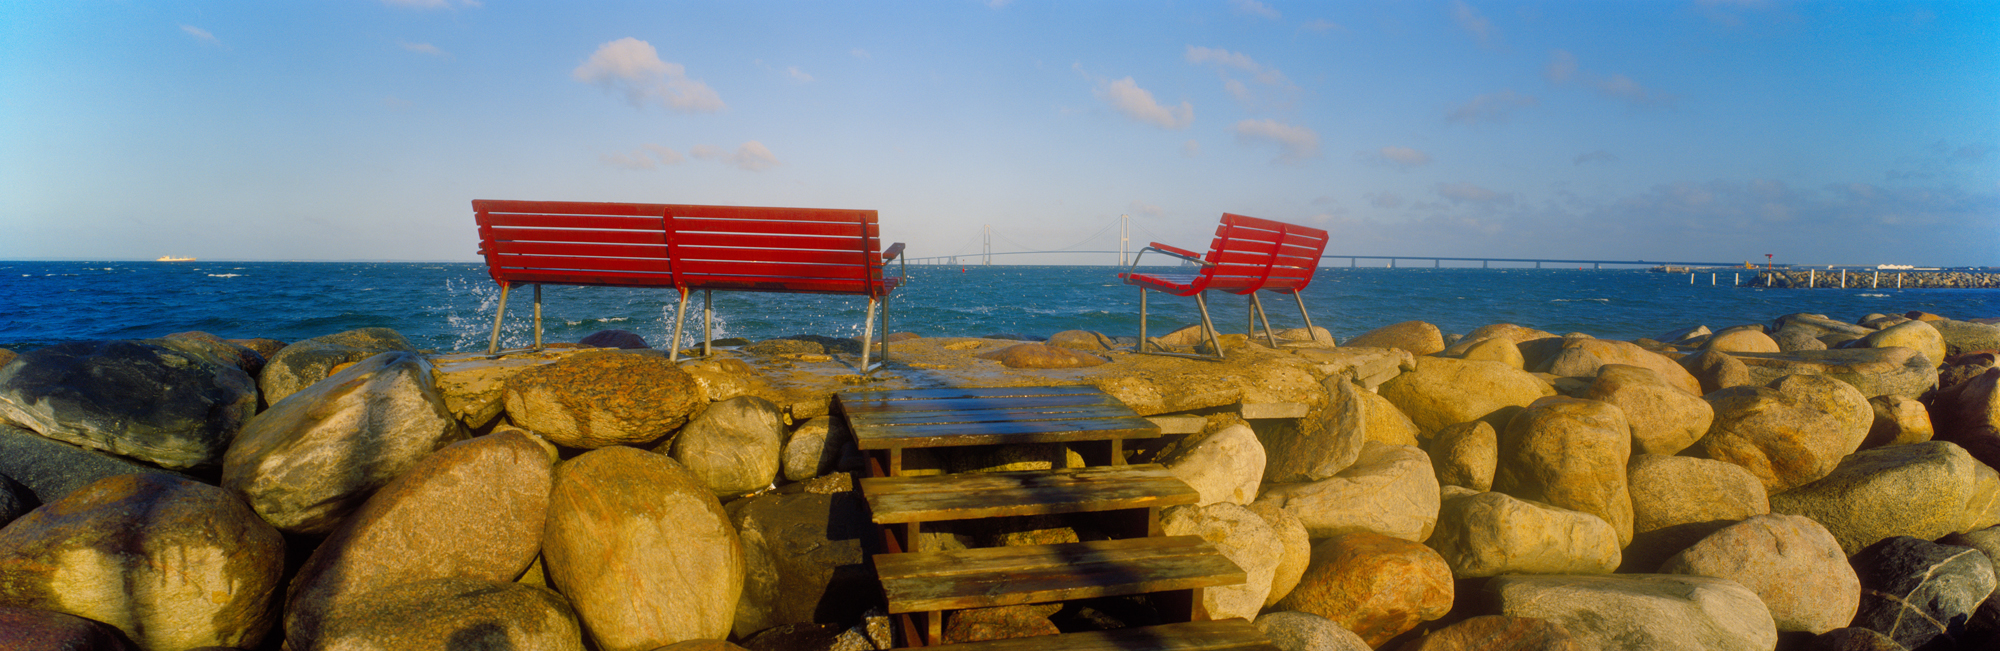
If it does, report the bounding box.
[0,260,2000,351]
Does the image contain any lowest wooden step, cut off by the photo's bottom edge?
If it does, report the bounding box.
[920,619,1278,651]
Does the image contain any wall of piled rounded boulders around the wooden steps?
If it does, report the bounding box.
[0,312,2000,651]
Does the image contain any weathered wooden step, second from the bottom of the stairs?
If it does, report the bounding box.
[874,535,1244,613]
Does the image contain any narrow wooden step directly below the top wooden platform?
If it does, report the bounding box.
[860,463,1202,525]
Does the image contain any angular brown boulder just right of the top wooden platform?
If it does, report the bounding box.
[1258,375,1374,483]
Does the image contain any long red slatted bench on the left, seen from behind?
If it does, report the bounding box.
[472,200,902,373]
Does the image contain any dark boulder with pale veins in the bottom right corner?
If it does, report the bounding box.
[1852,535,1996,649]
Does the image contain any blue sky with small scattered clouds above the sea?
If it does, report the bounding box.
[0,0,2000,266]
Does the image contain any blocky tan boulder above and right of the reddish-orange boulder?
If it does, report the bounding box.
[1426,493,1620,579]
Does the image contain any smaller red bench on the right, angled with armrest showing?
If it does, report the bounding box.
[1118,214,1326,359]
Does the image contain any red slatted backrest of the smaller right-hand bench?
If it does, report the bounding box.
[1202,214,1326,294]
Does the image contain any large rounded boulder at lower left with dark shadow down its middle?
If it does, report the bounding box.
[0,475,284,649]
